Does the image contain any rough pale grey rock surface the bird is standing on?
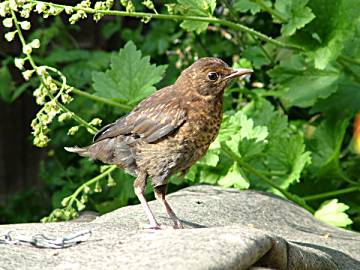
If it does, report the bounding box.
[0,186,360,270]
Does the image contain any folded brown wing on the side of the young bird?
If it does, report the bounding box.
[94,87,186,143]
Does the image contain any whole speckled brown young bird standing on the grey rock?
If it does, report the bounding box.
[65,57,252,229]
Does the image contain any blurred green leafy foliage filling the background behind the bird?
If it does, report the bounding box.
[0,0,360,230]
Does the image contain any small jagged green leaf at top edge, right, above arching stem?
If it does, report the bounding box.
[275,0,315,36]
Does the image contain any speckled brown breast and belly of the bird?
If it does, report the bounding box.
[137,90,223,186]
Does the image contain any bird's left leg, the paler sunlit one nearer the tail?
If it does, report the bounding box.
[134,172,160,229]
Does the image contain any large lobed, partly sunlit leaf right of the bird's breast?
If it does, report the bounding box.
[219,99,311,189]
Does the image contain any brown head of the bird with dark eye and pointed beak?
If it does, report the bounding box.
[175,57,253,96]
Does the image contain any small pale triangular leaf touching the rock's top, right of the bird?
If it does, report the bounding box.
[218,162,250,189]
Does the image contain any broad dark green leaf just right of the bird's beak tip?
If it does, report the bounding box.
[268,56,340,107]
